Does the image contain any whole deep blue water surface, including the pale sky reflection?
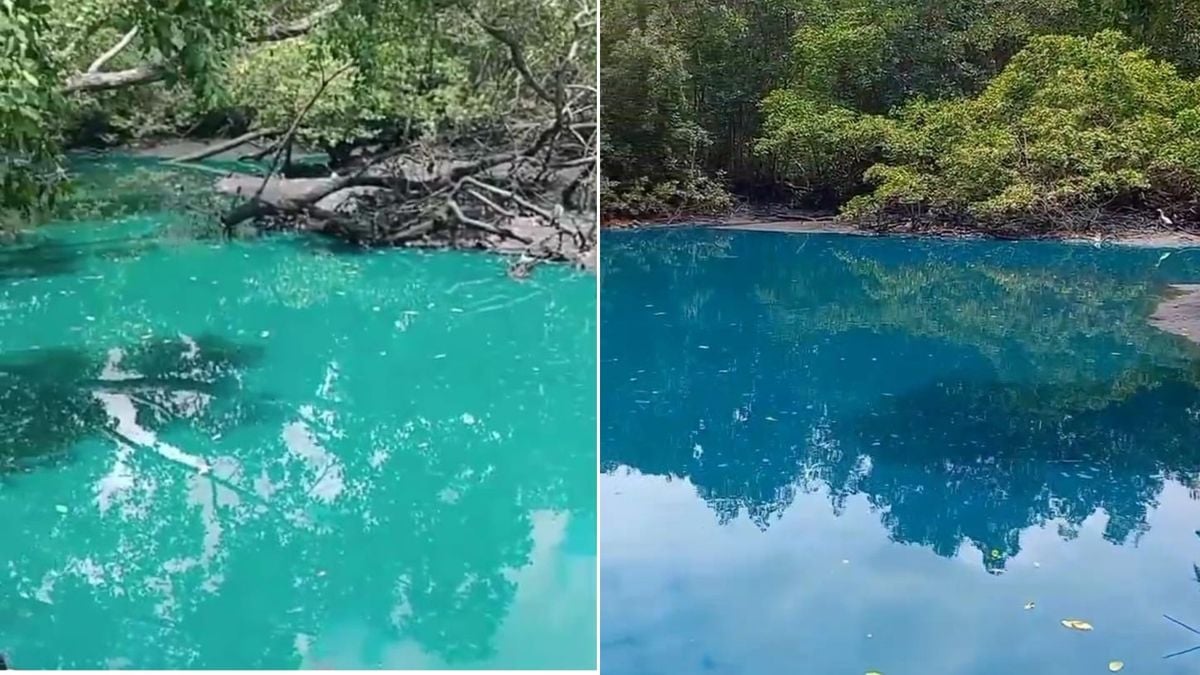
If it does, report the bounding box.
[600,229,1200,675]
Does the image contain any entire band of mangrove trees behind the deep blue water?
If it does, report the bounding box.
[601,0,1200,227]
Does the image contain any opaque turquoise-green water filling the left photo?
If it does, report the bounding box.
[0,160,596,669]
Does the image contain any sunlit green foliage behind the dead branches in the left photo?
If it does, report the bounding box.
[0,0,596,211]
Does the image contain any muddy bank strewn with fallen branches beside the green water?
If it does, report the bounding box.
[82,138,598,277]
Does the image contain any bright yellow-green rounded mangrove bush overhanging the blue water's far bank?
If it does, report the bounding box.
[851,31,1200,217]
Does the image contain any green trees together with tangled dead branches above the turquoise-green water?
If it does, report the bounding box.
[0,0,596,265]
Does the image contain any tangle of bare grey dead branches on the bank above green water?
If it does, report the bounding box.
[216,7,598,270]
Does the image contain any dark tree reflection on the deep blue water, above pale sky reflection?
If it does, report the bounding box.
[601,231,1200,572]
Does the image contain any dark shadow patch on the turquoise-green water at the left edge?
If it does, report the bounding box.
[0,335,271,476]
